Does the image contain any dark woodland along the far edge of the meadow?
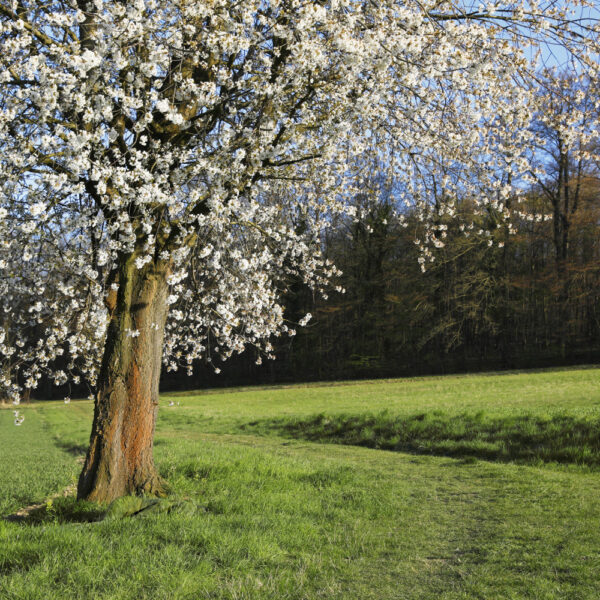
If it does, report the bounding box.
[157,166,600,388]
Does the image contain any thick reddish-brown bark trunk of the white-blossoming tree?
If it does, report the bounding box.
[77,255,168,502]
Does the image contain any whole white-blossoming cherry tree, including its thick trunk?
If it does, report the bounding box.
[0,0,598,501]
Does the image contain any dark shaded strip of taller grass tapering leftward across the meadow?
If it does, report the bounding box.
[242,411,600,470]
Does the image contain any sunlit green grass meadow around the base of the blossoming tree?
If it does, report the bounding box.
[0,369,600,600]
